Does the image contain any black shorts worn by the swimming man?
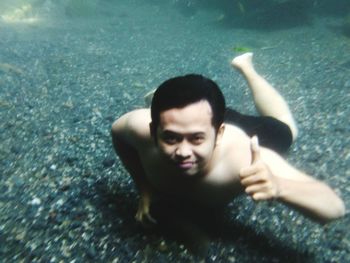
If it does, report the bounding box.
[225,108,293,154]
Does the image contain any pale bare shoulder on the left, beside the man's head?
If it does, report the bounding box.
[112,109,151,143]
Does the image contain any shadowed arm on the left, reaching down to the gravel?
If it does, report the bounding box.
[111,113,155,227]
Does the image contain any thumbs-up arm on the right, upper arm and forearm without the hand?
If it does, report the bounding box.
[261,148,345,222]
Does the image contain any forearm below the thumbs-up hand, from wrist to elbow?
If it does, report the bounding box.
[277,178,345,222]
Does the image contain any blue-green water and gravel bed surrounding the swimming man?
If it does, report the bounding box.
[0,0,350,263]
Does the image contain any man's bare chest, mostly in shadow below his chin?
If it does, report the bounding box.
[141,150,241,205]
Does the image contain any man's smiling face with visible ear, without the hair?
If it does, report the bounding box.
[156,101,223,176]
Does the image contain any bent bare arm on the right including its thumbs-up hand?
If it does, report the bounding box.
[240,139,345,222]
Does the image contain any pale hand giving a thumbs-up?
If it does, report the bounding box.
[240,136,279,201]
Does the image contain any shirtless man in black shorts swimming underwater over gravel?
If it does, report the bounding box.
[112,53,345,230]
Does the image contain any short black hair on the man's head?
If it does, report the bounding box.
[151,74,226,135]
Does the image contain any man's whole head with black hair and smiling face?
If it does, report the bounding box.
[150,75,225,176]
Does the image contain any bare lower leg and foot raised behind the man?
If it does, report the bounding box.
[231,53,298,141]
